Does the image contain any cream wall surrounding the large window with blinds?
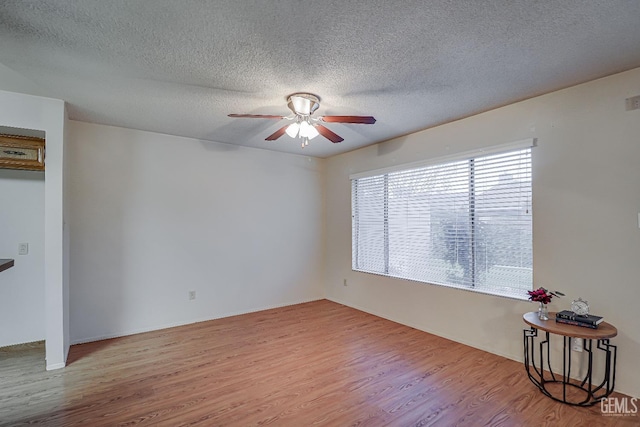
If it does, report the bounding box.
[326,69,640,396]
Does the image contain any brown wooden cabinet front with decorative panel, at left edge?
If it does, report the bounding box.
[0,134,45,171]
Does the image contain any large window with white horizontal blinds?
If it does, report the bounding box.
[351,140,533,297]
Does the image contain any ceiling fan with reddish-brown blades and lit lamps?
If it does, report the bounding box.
[229,92,376,148]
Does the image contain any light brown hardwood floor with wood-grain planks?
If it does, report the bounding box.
[0,300,640,427]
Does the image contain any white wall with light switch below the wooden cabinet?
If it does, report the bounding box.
[0,169,45,347]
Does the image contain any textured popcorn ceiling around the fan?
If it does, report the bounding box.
[0,0,640,157]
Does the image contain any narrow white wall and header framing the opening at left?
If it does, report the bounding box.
[0,88,69,369]
